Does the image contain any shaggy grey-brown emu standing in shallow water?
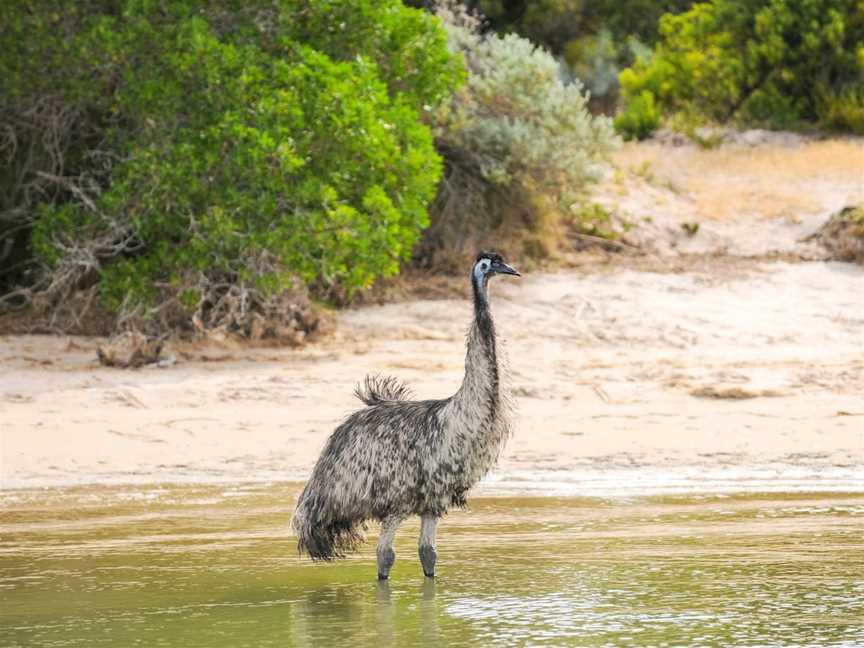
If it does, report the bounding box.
[292,252,520,580]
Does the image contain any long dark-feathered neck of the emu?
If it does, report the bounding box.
[453,275,500,427]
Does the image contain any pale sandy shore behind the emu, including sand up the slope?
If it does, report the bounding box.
[0,137,864,493]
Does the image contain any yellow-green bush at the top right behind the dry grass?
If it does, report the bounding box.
[618,0,864,137]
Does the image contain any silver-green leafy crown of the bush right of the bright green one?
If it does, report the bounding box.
[436,5,615,191]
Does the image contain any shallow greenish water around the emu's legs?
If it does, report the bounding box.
[0,484,864,647]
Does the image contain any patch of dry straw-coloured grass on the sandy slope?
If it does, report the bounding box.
[615,139,864,221]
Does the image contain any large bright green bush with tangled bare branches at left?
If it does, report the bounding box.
[0,0,463,334]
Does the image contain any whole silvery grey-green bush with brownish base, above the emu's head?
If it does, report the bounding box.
[421,6,615,260]
